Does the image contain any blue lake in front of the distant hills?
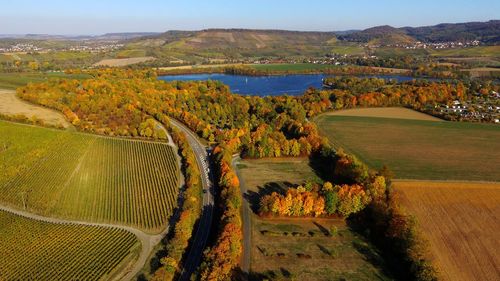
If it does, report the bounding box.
[159,74,415,96]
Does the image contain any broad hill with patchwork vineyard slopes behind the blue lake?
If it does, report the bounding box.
[126,29,336,60]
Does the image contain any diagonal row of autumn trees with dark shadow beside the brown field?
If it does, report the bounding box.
[311,146,437,281]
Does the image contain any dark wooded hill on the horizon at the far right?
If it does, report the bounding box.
[339,20,500,45]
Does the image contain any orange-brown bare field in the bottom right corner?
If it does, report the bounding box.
[394,181,500,281]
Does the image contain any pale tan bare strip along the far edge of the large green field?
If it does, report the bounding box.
[326,107,443,121]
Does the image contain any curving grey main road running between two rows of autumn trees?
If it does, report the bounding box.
[170,119,214,281]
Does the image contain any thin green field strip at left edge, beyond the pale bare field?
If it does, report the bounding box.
[0,72,89,89]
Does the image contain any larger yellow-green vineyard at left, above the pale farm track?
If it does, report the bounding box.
[0,121,180,233]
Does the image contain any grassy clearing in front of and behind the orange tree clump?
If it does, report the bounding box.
[237,158,390,280]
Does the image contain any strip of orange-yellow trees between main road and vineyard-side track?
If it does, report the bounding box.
[151,124,202,281]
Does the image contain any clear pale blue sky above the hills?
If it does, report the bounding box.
[0,0,500,35]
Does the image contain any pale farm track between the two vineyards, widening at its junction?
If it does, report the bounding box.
[0,203,168,280]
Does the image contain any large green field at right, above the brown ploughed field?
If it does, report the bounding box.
[316,112,500,181]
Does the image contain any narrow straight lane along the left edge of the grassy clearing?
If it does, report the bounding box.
[233,156,252,276]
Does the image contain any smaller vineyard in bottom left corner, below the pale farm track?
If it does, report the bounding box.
[0,211,140,280]
